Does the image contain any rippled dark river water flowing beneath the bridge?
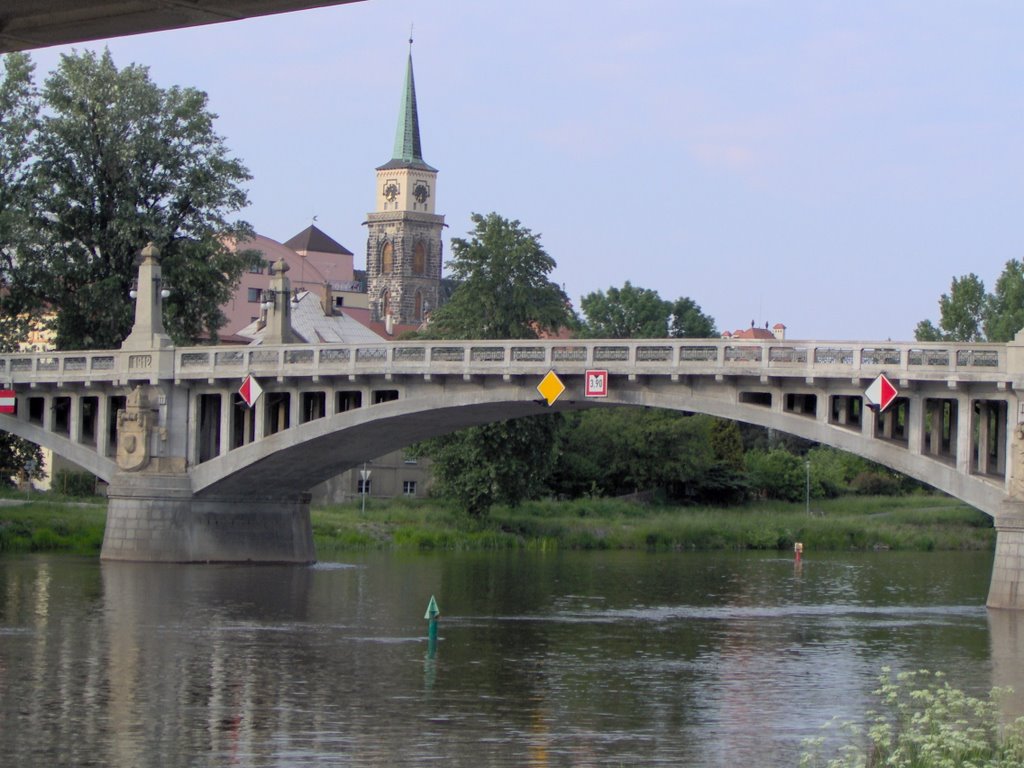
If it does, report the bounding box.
[0,552,1024,768]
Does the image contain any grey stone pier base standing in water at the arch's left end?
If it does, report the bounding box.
[100,472,316,564]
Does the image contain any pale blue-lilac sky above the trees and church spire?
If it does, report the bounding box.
[24,0,1024,340]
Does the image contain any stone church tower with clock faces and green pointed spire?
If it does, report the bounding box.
[367,40,444,326]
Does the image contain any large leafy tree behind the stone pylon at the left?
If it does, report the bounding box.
[10,51,252,349]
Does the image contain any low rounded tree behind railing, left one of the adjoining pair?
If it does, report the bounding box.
[580,281,672,339]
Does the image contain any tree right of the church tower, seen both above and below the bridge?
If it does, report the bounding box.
[416,213,574,519]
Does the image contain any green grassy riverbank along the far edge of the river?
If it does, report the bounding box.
[0,494,995,558]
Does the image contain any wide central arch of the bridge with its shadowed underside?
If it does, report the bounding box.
[191,385,1006,516]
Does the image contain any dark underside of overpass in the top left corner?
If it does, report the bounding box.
[0,0,360,53]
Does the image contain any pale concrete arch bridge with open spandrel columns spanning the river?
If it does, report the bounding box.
[6,338,1024,607]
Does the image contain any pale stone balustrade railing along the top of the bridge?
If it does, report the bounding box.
[0,339,1008,385]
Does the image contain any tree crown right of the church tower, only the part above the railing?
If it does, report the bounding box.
[427,213,573,339]
